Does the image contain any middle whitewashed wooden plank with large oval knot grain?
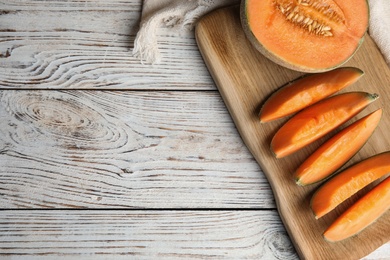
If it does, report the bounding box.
[0,90,275,208]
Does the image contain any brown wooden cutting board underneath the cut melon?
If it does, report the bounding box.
[195,6,390,260]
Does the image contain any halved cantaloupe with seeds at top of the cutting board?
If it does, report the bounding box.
[240,0,369,72]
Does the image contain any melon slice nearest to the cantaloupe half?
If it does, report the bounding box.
[259,67,364,122]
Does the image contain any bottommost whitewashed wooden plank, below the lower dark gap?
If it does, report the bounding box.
[0,210,390,260]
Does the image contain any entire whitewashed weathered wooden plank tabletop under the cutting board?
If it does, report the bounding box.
[0,0,390,259]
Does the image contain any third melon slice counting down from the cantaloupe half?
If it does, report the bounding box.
[294,109,382,186]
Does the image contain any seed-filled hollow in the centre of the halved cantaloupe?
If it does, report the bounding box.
[274,0,344,37]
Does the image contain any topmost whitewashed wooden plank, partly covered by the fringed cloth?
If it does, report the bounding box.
[0,0,215,90]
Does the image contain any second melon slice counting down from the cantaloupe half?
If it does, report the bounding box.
[271,92,378,158]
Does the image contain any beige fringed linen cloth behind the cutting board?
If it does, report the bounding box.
[133,0,390,66]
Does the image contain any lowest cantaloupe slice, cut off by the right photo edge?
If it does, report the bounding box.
[324,177,390,242]
